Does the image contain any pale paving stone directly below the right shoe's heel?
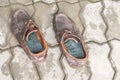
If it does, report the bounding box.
[61,57,90,80]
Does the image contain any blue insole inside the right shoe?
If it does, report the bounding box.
[65,39,85,58]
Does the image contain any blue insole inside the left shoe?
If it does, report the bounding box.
[26,32,43,54]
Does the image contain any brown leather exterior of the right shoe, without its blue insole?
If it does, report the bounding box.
[53,14,87,67]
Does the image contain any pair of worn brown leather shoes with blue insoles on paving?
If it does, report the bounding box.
[11,9,88,66]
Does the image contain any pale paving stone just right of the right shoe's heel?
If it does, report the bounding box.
[87,43,114,80]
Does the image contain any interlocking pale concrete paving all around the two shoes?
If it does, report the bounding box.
[0,0,120,80]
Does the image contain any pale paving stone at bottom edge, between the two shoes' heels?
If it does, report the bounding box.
[37,47,64,80]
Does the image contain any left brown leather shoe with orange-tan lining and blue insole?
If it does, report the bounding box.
[11,9,48,61]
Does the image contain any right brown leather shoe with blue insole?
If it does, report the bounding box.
[53,14,88,67]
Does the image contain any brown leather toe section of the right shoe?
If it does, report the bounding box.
[53,14,76,40]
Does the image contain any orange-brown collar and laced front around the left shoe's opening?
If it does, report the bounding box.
[22,20,48,57]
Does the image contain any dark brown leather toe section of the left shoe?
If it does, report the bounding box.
[11,9,31,41]
